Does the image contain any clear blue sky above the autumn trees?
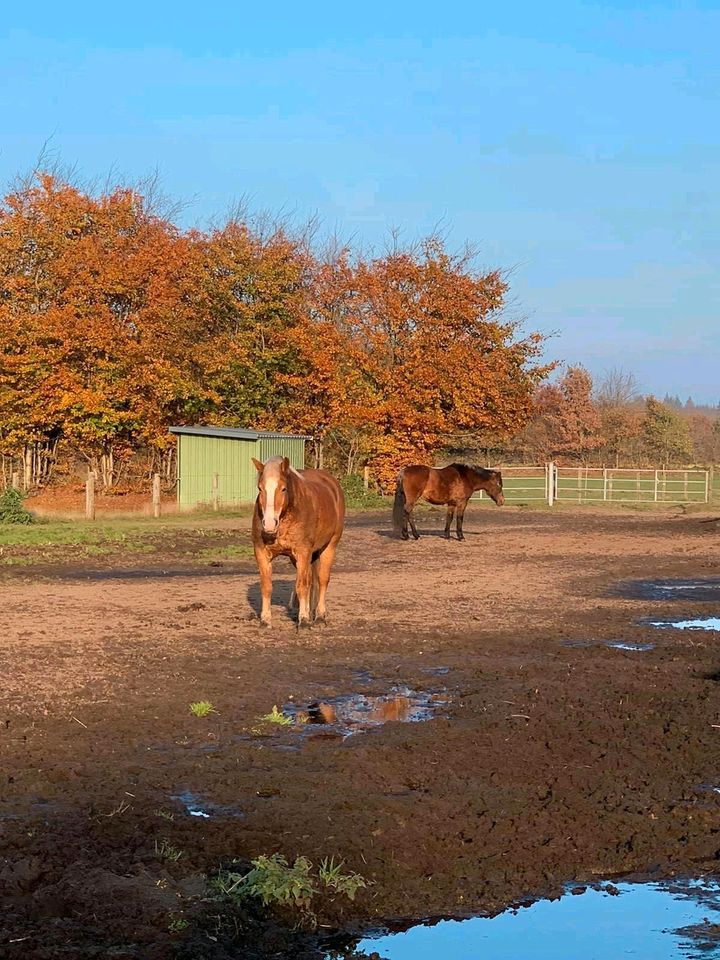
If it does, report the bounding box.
[0,0,720,402]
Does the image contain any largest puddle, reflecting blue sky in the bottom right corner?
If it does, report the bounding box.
[340,880,720,960]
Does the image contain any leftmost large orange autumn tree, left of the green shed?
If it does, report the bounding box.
[0,175,211,486]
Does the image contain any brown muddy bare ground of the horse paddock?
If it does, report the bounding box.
[0,507,720,958]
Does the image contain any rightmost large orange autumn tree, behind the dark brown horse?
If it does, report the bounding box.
[306,237,546,482]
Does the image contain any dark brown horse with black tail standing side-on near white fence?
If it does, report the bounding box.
[393,463,505,540]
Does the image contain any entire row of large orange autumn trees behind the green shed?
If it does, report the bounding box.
[0,175,547,485]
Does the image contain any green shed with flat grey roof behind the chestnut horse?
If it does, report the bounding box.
[170,427,308,510]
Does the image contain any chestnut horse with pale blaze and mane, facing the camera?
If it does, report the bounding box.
[252,457,345,627]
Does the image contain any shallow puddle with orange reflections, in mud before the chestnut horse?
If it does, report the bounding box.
[283,687,447,736]
